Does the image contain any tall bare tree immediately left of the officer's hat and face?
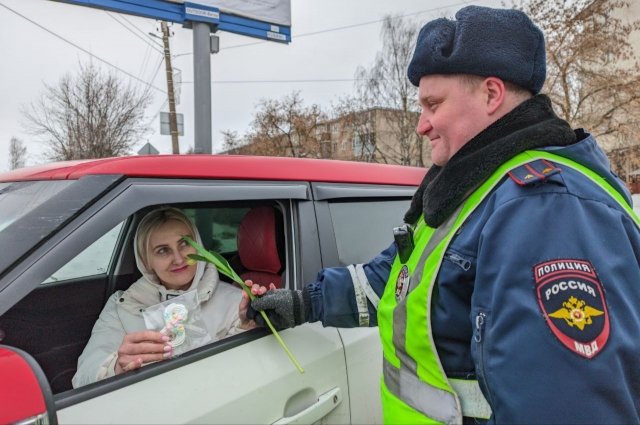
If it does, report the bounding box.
[348,16,428,166]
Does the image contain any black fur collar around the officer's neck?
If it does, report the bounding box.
[404,95,576,227]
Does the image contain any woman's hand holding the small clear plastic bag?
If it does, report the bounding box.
[115,330,171,375]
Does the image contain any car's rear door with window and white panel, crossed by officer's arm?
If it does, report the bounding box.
[312,183,416,423]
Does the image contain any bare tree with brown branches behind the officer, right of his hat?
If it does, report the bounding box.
[520,0,640,146]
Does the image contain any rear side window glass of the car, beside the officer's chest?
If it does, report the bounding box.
[329,199,410,264]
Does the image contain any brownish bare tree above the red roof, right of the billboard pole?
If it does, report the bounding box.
[228,92,326,158]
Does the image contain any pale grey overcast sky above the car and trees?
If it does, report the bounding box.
[0,0,501,171]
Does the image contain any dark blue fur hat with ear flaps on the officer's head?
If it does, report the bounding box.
[407,6,547,94]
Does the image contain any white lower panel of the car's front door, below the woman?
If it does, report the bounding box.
[58,324,350,424]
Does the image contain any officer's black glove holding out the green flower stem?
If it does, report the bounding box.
[247,288,311,330]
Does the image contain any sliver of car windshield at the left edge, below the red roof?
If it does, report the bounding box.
[0,180,74,232]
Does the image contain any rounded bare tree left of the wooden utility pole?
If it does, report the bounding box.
[23,63,151,160]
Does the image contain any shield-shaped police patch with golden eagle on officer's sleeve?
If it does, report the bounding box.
[533,259,610,359]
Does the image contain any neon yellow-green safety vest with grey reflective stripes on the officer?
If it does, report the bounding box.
[378,151,640,423]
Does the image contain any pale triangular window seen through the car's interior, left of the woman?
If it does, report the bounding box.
[42,222,124,285]
